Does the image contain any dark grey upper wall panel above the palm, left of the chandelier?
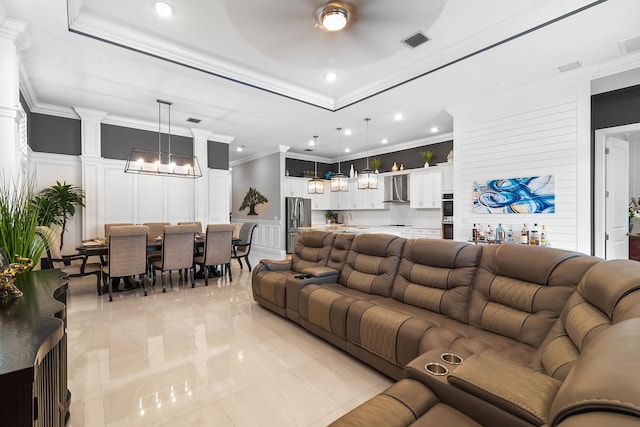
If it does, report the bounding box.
[28,112,82,156]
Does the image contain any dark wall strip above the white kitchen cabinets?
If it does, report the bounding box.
[285,141,453,177]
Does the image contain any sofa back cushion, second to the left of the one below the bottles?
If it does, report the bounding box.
[340,233,406,297]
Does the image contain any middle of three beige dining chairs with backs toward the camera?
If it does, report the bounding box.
[151,224,197,292]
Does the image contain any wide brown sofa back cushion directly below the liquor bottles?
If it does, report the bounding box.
[469,243,600,347]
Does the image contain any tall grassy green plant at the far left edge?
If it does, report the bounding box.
[0,176,47,264]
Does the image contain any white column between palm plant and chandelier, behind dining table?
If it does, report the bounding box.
[73,107,107,239]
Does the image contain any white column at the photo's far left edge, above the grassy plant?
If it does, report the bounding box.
[0,18,30,176]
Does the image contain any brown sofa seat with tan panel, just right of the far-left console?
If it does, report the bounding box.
[298,283,380,339]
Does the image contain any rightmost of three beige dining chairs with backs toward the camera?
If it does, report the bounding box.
[195,224,234,286]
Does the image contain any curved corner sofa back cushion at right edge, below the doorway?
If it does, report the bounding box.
[538,260,640,379]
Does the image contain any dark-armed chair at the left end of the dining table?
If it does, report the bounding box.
[36,226,102,295]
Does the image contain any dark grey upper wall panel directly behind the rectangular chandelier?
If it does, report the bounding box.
[100,124,192,163]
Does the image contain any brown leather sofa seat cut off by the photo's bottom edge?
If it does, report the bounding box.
[330,379,480,427]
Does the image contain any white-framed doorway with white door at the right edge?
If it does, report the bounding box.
[593,123,640,259]
